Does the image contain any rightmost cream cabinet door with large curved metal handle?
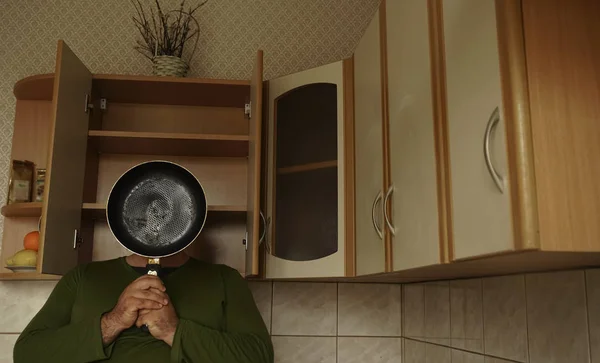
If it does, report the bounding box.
[441,0,514,259]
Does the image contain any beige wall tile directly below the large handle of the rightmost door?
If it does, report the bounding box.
[483,275,527,362]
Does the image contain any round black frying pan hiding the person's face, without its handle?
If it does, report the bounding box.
[106,161,207,258]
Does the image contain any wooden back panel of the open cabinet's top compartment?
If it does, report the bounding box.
[102,102,248,135]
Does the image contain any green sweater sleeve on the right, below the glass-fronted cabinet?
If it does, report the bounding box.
[171,269,273,363]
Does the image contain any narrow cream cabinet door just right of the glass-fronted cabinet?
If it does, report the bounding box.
[353,12,385,275]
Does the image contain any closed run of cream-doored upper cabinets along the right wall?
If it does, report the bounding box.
[355,0,600,281]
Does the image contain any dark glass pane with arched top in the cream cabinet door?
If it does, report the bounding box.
[272,83,338,261]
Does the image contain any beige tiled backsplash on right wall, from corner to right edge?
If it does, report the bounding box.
[403,269,600,363]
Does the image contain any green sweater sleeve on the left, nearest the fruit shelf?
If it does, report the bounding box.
[14,267,112,363]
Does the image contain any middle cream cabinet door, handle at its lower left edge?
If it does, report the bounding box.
[382,1,446,271]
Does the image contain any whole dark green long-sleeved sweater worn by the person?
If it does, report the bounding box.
[14,258,273,363]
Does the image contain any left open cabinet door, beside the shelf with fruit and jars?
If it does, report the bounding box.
[38,40,92,275]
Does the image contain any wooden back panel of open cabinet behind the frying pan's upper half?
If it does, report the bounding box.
[96,154,248,206]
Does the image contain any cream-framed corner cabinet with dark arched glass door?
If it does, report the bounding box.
[265,60,354,278]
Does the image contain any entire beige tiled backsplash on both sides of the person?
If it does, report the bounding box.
[0,269,600,363]
